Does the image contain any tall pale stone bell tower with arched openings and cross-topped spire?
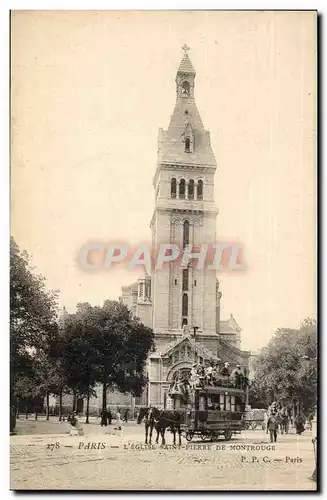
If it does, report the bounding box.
[151,45,218,340]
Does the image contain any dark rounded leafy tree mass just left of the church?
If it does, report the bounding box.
[65,300,154,409]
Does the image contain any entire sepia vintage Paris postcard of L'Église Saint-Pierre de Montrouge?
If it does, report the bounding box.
[10,11,319,492]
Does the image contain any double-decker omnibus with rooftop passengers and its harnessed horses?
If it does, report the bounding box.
[137,364,248,445]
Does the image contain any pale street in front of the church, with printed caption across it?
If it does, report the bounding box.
[10,418,316,490]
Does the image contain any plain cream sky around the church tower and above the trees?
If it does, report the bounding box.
[11,11,317,350]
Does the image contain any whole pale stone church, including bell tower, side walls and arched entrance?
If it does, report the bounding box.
[120,45,250,407]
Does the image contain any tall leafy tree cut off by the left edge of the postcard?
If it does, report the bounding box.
[10,238,57,426]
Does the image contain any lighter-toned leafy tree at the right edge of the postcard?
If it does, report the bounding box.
[254,318,317,411]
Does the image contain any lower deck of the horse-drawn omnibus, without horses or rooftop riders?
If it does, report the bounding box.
[170,386,245,441]
